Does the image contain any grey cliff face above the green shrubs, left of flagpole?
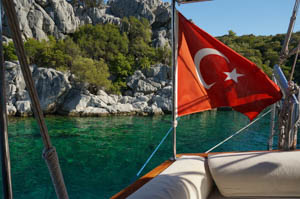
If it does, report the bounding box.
[3,0,171,47]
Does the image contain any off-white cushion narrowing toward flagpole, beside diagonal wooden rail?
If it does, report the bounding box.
[128,156,213,199]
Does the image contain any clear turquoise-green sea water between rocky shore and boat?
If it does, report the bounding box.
[0,111,270,199]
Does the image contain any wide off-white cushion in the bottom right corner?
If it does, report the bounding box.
[208,151,300,197]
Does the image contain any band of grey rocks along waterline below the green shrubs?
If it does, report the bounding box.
[4,62,172,116]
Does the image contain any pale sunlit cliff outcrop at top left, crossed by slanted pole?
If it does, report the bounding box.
[3,0,80,40]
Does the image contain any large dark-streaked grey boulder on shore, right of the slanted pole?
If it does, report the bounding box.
[33,68,71,113]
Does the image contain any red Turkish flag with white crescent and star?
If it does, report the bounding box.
[175,12,282,120]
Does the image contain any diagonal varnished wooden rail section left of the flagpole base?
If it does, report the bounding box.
[111,160,174,199]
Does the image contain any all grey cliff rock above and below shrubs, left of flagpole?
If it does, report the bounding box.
[4,0,172,116]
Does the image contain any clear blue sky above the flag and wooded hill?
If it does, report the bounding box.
[163,0,300,36]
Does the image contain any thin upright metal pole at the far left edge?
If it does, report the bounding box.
[0,0,13,199]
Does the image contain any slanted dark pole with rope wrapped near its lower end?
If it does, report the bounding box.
[3,0,69,199]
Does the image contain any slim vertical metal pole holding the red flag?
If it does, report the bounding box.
[172,0,177,160]
